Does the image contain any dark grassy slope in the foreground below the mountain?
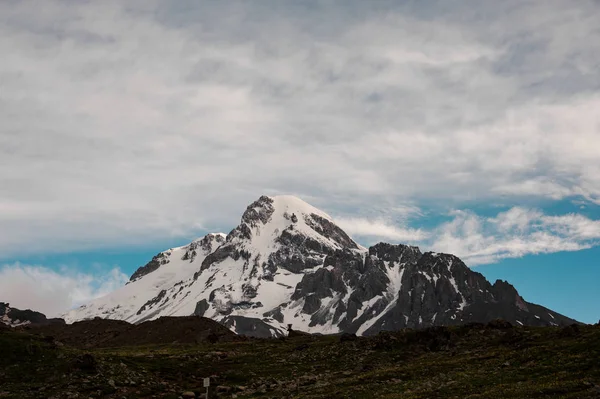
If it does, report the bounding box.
[0,323,600,398]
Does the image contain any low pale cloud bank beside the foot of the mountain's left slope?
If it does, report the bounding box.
[0,263,129,317]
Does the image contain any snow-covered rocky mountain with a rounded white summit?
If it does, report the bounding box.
[64,196,575,336]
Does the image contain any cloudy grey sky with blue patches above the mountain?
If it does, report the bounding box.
[0,0,600,322]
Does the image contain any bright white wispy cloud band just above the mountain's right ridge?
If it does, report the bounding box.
[335,207,600,266]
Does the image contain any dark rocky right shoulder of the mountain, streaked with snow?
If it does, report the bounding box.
[291,243,575,335]
